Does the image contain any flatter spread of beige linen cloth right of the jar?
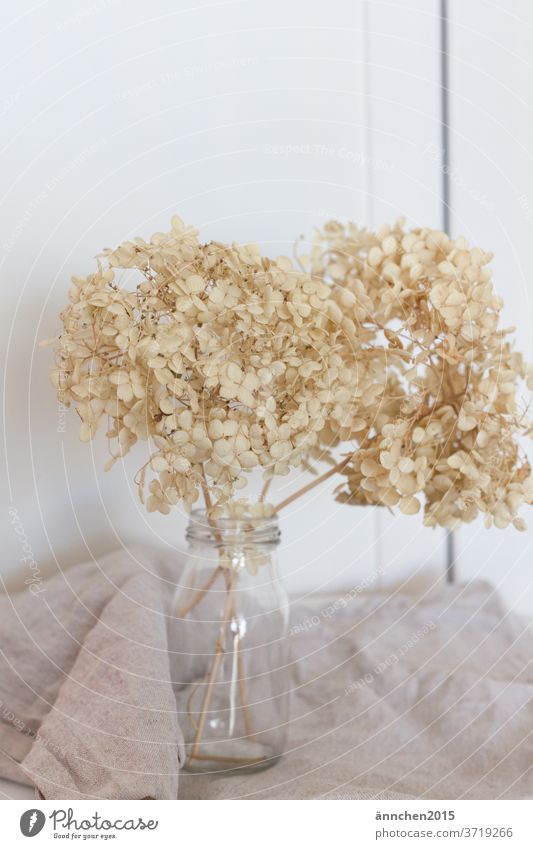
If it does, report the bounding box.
[0,582,533,800]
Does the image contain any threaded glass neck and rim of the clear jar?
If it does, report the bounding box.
[187,510,281,548]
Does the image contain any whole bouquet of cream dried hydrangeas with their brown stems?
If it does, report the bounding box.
[54,217,533,754]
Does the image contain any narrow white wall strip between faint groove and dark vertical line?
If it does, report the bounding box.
[366,0,446,583]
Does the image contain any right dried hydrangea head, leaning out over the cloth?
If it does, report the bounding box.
[309,221,533,530]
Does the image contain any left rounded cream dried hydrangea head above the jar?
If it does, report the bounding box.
[55,217,339,515]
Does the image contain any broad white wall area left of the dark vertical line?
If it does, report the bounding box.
[0,0,454,592]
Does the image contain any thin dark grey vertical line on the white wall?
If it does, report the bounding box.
[440,0,455,583]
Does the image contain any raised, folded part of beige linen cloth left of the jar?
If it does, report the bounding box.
[0,550,183,799]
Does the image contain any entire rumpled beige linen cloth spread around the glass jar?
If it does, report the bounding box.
[0,552,533,799]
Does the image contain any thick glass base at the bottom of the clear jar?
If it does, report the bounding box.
[183,740,281,774]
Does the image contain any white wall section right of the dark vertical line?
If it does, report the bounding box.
[449,0,533,614]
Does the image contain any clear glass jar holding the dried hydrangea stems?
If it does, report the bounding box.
[170,510,289,772]
